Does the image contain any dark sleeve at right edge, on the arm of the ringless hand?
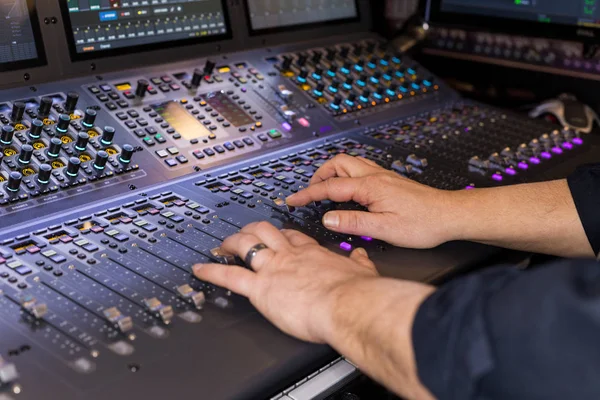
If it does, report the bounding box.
[568,164,600,254]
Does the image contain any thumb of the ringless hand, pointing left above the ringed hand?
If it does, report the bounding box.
[323,211,386,238]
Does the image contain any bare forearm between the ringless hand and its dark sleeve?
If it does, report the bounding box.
[447,180,594,257]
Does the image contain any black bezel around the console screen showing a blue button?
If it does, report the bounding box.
[59,0,233,62]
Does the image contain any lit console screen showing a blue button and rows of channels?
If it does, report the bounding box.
[61,0,230,60]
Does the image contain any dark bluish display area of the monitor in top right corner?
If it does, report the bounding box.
[441,0,600,27]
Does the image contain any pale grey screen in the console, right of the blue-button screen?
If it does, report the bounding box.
[248,0,358,32]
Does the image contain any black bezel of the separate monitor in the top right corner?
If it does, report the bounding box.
[422,0,600,43]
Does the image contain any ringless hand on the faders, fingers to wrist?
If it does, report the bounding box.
[287,155,458,248]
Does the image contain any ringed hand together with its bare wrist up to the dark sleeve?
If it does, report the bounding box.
[194,222,434,400]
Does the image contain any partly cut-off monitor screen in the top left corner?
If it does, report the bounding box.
[0,0,45,71]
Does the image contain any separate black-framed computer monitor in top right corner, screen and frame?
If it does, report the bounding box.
[426,0,600,41]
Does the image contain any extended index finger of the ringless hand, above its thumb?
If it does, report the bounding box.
[286,178,371,207]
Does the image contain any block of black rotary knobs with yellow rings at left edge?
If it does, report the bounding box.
[0,92,138,204]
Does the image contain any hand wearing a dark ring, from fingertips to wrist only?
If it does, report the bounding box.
[194,222,377,343]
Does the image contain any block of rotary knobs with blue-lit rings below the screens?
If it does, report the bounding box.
[276,41,439,116]
